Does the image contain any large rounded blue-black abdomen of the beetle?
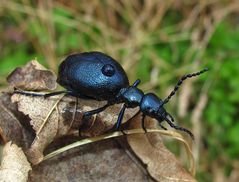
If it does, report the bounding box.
[57,52,129,101]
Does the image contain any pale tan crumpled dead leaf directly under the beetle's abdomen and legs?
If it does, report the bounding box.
[12,94,137,164]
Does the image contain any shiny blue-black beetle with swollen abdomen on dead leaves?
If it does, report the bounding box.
[15,52,208,138]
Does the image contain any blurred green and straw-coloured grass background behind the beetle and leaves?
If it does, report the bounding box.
[0,0,239,181]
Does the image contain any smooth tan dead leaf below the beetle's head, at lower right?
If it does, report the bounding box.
[127,114,196,182]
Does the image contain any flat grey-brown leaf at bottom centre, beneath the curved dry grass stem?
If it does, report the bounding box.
[29,137,151,182]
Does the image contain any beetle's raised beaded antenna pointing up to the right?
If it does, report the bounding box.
[162,68,208,106]
